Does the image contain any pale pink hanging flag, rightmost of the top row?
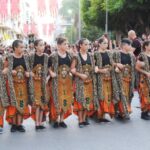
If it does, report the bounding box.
[49,0,58,18]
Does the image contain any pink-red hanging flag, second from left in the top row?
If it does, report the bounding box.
[10,0,20,17]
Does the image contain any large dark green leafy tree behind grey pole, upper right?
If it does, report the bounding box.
[82,0,150,34]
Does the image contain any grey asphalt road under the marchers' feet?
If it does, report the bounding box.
[0,93,150,150]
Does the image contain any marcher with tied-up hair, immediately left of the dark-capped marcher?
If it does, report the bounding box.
[94,37,116,122]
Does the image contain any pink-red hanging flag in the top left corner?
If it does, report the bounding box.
[0,0,8,19]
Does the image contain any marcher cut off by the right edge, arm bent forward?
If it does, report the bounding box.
[136,41,150,120]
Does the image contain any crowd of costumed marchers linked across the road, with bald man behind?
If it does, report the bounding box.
[0,30,150,133]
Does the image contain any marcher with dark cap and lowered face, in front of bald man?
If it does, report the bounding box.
[114,39,135,119]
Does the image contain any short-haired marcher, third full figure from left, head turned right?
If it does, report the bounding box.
[49,37,73,128]
